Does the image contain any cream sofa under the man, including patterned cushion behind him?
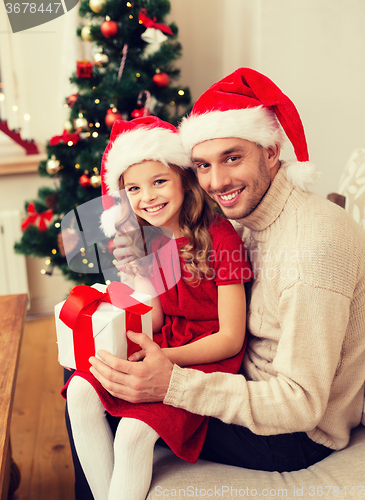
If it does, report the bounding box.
[147,149,365,500]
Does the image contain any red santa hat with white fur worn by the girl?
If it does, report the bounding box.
[101,116,192,237]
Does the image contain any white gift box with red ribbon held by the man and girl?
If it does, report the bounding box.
[55,282,152,372]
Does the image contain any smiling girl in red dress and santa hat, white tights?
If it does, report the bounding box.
[63,117,251,500]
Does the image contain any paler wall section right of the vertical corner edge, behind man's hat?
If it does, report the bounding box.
[258,0,365,195]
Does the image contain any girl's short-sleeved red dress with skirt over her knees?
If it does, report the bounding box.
[61,216,252,463]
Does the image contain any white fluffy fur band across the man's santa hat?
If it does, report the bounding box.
[179,106,284,154]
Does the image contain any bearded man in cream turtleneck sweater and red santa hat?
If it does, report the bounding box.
[83,68,365,471]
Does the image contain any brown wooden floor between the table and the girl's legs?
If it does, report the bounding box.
[11,317,75,500]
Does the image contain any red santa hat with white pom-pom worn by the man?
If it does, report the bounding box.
[180,68,318,190]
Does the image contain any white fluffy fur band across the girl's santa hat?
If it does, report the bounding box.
[105,127,191,196]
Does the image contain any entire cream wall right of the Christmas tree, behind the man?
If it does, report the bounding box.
[170,0,365,196]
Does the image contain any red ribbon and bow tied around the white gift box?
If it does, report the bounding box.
[60,281,152,372]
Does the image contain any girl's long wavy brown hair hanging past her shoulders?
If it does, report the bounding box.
[115,164,215,284]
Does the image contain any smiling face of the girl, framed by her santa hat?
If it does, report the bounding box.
[123,160,185,238]
